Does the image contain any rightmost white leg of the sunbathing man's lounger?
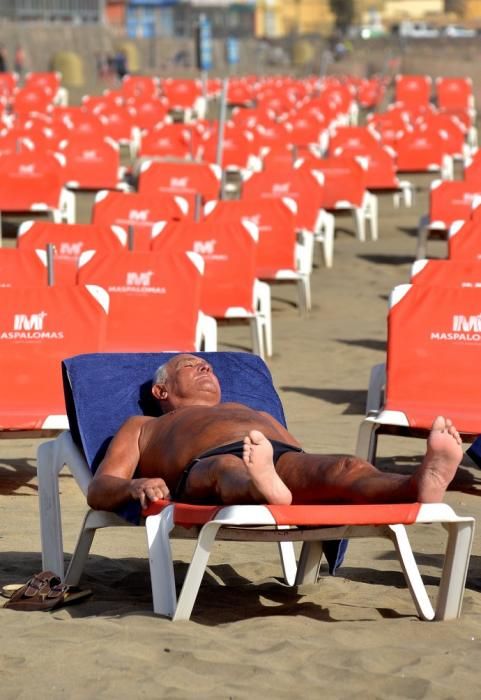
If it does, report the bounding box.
[436,521,474,620]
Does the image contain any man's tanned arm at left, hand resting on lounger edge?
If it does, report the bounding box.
[87,416,169,510]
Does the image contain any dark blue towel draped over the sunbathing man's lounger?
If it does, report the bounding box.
[62,352,346,573]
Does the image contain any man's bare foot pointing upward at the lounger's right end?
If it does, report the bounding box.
[414,416,463,503]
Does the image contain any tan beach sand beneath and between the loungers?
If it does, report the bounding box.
[0,171,481,700]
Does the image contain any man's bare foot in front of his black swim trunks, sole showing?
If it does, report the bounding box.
[243,430,292,505]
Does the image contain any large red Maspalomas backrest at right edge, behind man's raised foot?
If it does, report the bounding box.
[385,284,481,434]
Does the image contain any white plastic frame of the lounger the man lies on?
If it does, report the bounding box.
[38,432,474,620]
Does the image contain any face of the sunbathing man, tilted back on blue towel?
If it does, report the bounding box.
[160,355,220,408]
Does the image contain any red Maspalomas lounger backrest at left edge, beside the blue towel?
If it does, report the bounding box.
[0,286,108,430]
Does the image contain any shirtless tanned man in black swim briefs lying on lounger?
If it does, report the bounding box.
[88,354,462,510]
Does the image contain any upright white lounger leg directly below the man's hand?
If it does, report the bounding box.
[145,507,177,618]
